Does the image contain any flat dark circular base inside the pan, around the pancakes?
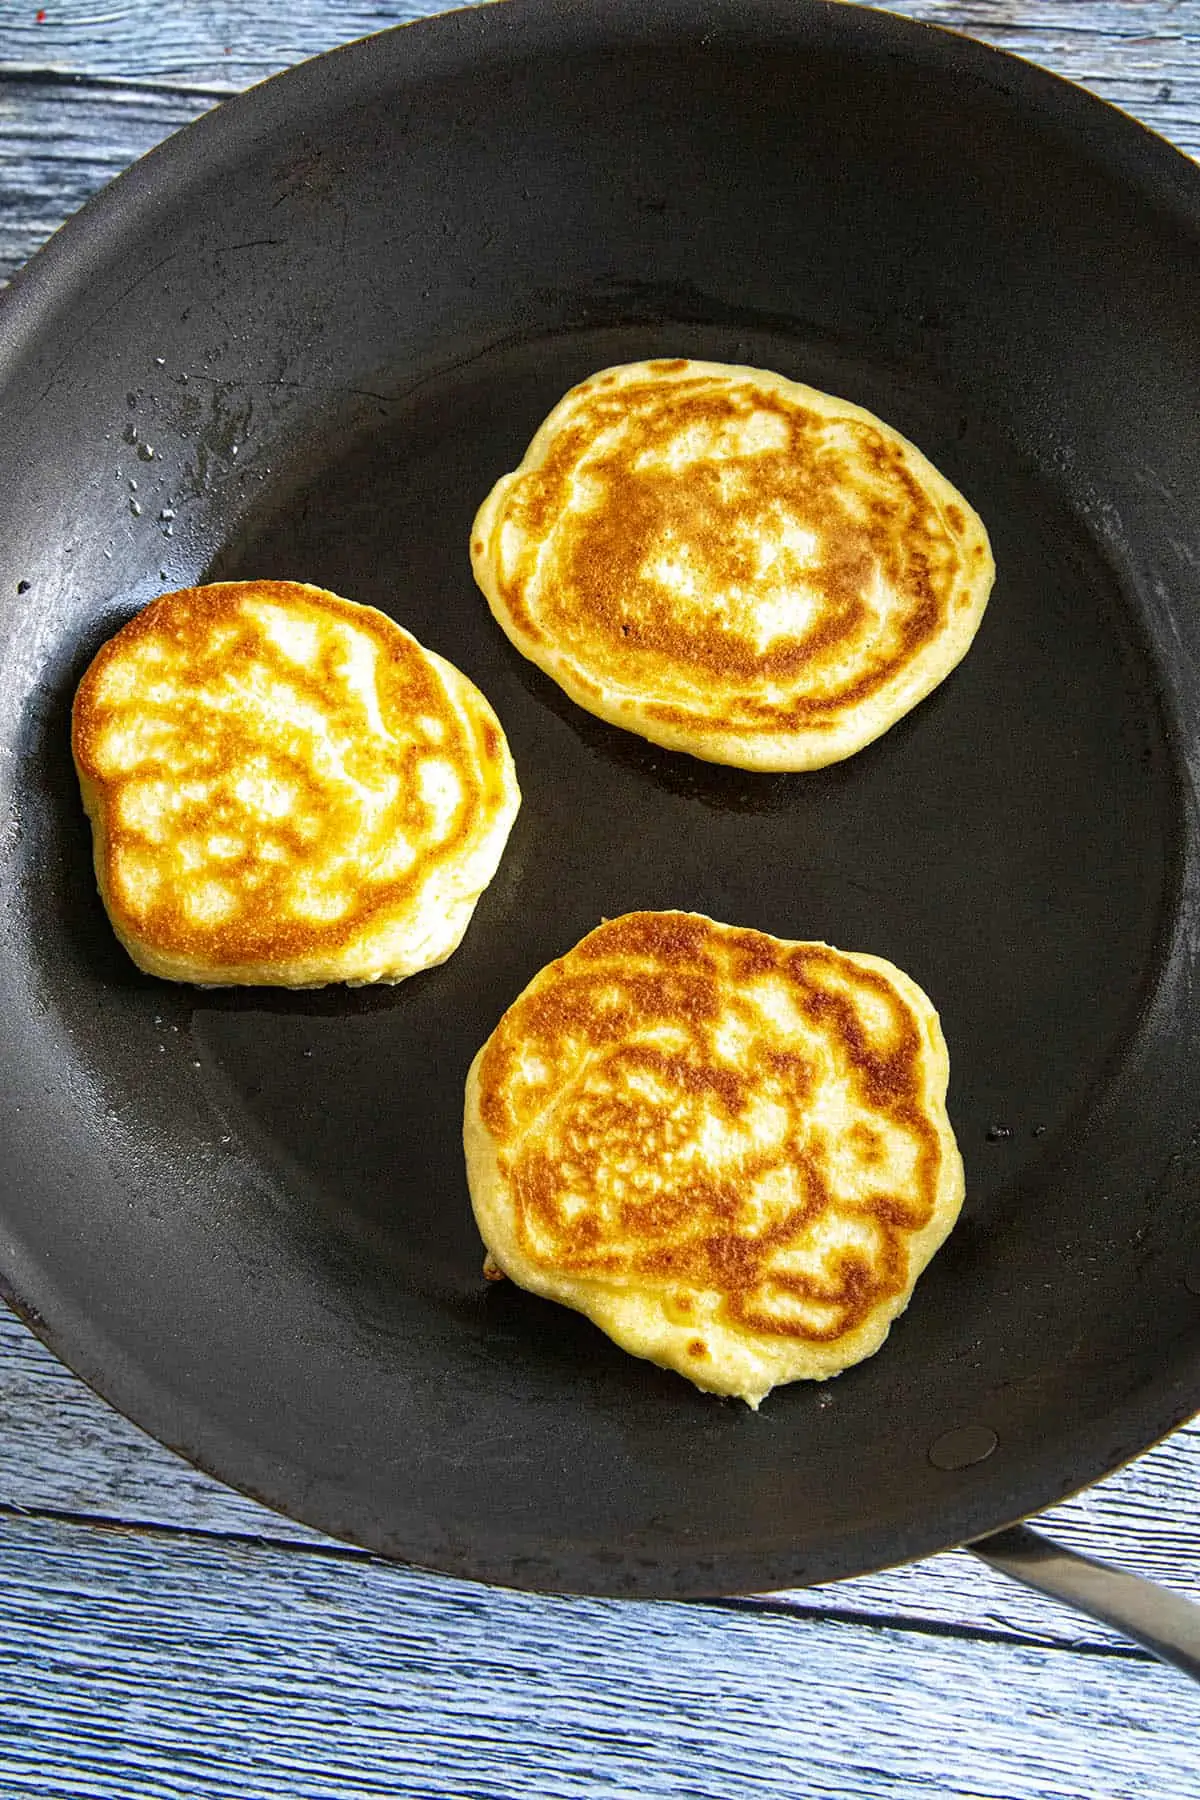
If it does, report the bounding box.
[199,326,1175,1281]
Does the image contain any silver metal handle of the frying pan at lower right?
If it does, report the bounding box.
[964,1525,1200,1681]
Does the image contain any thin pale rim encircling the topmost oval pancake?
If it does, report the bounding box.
[470,360,995,772]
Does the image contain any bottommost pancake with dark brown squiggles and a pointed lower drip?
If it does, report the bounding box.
[464,913,963,1408]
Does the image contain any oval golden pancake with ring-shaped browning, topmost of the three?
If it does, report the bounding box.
[471,358,995,769]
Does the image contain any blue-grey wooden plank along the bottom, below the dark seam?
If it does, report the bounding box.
[0,1523,1200,1800]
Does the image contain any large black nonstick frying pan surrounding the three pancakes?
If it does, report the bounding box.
[0,0,1200,1660]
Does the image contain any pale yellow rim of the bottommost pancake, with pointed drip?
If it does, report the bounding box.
[462,913,966,1411]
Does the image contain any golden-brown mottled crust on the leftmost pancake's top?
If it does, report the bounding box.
[72,581,518,979]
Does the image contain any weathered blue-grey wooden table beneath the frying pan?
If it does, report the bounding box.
[0,0,1200,1800]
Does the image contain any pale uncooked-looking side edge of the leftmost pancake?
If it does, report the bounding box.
[72,583,522,988]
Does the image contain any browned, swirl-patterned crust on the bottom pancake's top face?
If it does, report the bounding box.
[475,913,961,1357]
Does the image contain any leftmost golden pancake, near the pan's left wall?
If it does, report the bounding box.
[72,581,520,988]
